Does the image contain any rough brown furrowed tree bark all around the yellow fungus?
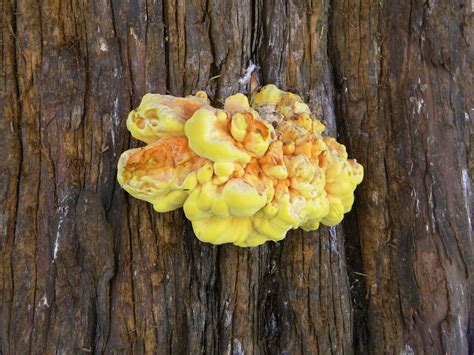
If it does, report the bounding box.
[0,0,468,354]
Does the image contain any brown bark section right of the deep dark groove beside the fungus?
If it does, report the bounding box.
[331,0,473,354]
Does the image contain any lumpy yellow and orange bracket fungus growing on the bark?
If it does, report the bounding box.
[118,85,363,246]
